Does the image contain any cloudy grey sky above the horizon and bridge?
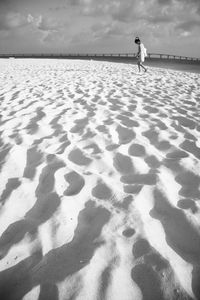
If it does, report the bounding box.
[0,0,200,57]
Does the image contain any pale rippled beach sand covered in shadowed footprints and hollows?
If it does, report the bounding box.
[0,59,200,300]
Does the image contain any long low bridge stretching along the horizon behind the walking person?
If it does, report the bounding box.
[0,53,200,62]
